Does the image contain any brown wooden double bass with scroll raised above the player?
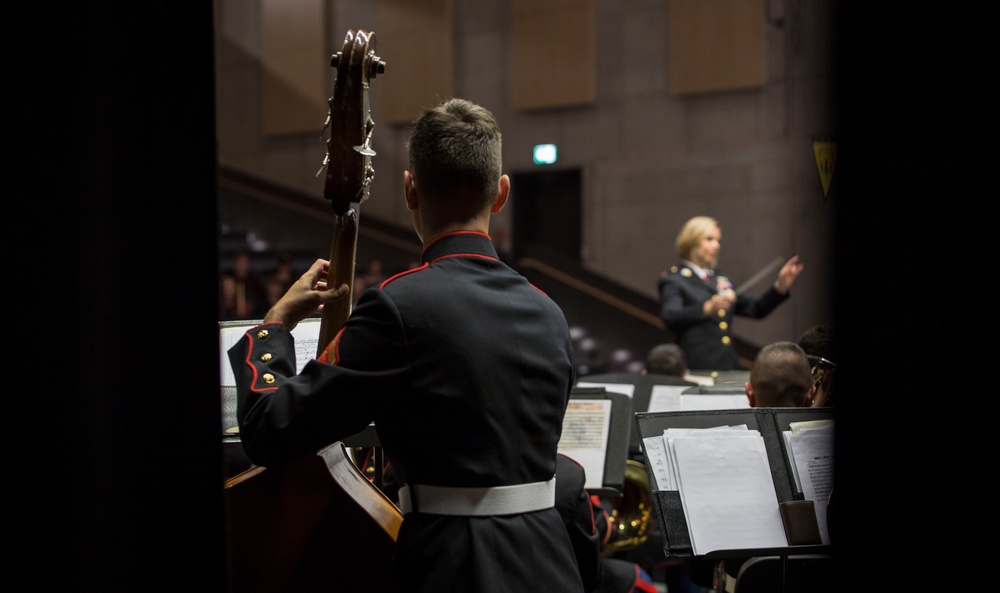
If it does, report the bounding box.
[224,29,402,593]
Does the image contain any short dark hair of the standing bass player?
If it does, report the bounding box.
[407,99,502,218]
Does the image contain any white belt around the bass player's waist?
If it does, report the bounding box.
[399,477,556,516]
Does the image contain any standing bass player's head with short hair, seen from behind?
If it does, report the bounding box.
[403,99,510,243]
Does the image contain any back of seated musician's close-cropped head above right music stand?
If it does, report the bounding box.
[745,341,815,408]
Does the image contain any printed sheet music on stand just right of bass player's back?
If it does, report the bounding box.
[557,399,611,488]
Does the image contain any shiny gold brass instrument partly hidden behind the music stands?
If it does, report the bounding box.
[605,459,653,552]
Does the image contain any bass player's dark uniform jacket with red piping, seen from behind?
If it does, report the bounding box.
[229,232,582,593]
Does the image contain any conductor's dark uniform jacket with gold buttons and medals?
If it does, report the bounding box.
[659,263,789,371]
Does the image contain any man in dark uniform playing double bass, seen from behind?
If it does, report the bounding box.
[229,99,583,593]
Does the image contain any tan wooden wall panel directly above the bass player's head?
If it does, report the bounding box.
[376,0,455,124]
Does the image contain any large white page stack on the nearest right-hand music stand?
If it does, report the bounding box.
[668,430,788,555]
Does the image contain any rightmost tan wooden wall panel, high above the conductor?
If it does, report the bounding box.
[667,0,767,95]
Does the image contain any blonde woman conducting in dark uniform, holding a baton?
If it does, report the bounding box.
[658,216,804,371]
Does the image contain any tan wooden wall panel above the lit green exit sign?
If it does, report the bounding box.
[510,0,597,110]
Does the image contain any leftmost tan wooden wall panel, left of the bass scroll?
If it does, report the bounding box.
[260,0,332,135]
